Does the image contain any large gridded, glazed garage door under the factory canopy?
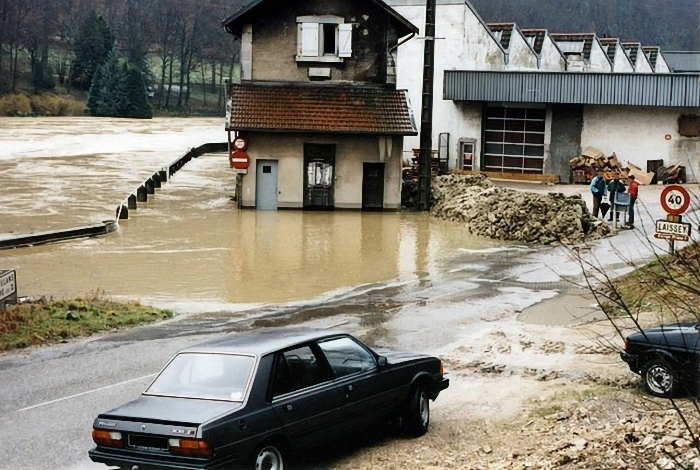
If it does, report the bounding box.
[482,106,547,174]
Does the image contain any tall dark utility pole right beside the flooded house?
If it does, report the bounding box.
[418,0,436,211]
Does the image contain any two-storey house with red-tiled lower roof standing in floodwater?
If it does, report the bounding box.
[223,0,420,210]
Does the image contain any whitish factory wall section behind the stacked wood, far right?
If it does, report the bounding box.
[581,106,700,179]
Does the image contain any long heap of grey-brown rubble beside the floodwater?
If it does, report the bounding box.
[431,174,612,245]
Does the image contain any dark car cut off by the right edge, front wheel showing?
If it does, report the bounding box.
[620,323,700,398]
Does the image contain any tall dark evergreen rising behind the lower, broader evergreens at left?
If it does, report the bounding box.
[71,11,113,90]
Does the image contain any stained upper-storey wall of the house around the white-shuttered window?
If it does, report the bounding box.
[242,0,398,84]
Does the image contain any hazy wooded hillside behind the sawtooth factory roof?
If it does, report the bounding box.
[471,0,700,50]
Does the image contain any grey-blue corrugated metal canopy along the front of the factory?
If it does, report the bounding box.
[443,71,700,107]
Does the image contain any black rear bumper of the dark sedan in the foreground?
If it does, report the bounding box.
[88,448,233,470]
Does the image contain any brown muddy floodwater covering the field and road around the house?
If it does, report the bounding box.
[0,118,500,311]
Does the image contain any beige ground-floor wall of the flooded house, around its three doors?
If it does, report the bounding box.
[242,132,403,210]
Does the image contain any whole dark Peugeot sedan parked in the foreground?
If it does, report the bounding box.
[89,329,449,470]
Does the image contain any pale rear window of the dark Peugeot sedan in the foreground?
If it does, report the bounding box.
[144,353,255,401]
